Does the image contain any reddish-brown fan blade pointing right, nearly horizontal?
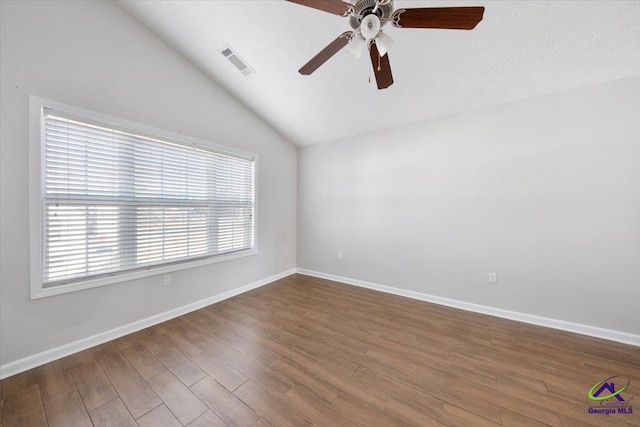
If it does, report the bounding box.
[391,6,484,30]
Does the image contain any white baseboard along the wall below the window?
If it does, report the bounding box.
[0,268,296,379]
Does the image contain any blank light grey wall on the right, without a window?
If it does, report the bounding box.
[298,77,640,334]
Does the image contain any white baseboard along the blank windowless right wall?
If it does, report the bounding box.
[297,268,640,347]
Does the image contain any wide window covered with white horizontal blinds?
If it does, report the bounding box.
[32,98,255,297]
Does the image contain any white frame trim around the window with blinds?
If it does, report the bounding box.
[29,95,259,300]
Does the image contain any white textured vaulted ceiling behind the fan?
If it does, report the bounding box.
[118,0,640,145]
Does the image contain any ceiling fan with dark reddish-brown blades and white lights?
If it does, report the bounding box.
[287,0,484,89]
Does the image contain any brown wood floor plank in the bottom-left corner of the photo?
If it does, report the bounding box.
[2,384,47,427]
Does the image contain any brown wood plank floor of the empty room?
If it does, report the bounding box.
[0,275,640,427]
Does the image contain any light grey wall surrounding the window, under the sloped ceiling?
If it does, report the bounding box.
[0,1,296,365]
